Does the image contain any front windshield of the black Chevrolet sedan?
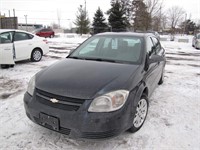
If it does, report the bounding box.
[69,35,144,64]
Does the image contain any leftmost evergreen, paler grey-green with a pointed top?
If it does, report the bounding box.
[74,5,90,35]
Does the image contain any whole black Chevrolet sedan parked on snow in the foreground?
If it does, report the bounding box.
[24,32,166,139]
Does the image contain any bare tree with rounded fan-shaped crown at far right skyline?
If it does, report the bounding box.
[167,6,185,31]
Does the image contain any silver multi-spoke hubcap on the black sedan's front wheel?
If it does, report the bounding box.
[133,99,147,128]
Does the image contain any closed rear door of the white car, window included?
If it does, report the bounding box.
[14,32,34,61]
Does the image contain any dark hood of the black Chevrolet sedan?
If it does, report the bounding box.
[36,58,138,99]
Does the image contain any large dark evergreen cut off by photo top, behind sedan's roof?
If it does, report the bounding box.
[107,0,128,32]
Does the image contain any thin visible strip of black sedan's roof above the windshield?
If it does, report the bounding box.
[96,32,154,37]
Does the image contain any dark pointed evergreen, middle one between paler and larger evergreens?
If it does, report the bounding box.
[92,7,108,34]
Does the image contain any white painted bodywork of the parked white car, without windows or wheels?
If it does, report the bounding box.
[0,30,49,64]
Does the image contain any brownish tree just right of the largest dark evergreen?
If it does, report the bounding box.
[132,0,151,31]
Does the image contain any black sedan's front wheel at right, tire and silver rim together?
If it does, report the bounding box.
[129,95,149,133]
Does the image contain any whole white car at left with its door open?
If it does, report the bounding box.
[0,29,49,67]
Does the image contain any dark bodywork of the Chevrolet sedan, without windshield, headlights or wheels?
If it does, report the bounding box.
[24,33,166,139]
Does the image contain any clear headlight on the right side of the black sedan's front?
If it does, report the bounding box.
[88,90,129,112]
